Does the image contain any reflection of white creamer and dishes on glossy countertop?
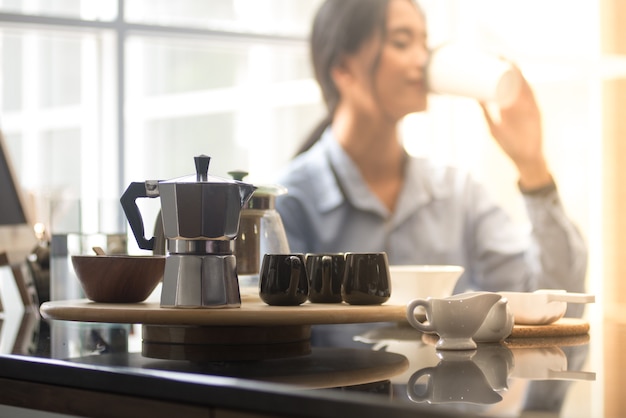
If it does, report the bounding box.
[354,324,596,416]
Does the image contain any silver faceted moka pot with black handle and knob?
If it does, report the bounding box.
[120,155,255,308]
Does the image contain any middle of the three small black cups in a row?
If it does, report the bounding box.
[306,253,346,303]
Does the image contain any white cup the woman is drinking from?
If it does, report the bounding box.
[426,44,522,107]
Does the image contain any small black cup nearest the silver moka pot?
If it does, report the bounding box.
[259,254,309,306]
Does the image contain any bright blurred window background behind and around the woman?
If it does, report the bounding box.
[0,0,626,411]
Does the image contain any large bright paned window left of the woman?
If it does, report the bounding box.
[0,0,323,242]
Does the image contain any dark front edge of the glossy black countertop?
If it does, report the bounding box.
[0,355,434,417]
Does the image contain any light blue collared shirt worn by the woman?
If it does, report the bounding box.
[277,129,587,310]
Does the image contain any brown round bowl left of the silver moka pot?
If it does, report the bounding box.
[72,255,165,303]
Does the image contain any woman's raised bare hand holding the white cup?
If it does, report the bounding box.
[481,69,552,190]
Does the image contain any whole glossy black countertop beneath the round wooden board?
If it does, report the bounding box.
[0,298,604,417]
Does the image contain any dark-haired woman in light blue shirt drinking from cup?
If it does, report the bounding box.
[277,0,587,314]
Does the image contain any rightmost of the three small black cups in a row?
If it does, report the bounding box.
[341,252,391,305]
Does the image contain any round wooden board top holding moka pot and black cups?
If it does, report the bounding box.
[40,297,406,326]
